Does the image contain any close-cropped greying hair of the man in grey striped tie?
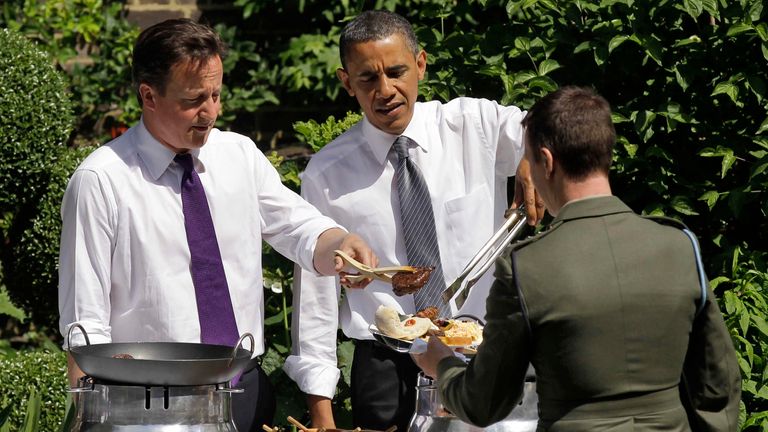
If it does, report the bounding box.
[339,10,419,68]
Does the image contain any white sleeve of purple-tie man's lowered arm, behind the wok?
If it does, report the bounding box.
[59,169,115,349]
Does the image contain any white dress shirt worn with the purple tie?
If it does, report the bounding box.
[59,122,338,355]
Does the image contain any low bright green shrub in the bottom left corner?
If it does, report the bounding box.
[0,350,68,432]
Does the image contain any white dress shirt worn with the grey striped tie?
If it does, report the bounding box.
[284,98,525,397]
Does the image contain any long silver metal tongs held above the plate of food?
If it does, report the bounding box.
[442,206,526,315]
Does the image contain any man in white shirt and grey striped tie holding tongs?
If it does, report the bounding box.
[285,11,543,430]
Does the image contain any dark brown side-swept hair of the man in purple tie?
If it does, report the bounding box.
[133,18,227,104]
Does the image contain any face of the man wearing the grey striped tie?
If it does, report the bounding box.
[336,34,427,135]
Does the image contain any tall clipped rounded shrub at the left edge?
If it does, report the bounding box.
[0,29,73,330]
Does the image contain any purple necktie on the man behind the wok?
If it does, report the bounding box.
[174,153,239,346]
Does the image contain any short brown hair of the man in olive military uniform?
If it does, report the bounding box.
[522,86,616,180]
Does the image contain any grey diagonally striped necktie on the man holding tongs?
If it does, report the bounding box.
[393,136,448,317]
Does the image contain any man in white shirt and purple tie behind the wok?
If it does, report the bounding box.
[59,19,377,432]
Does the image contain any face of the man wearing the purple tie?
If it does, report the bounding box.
[139,56,224,153]
